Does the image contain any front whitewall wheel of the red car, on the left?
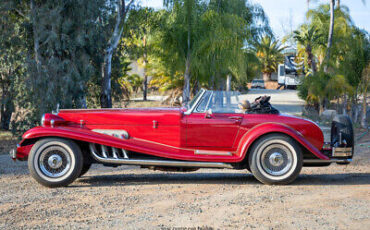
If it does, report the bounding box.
[28,138,83,187]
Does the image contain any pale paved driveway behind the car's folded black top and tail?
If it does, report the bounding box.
[240,89,305,115]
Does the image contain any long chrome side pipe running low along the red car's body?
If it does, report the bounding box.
[89,143,233,169]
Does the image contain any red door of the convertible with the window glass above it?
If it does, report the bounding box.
[186,92,243,148]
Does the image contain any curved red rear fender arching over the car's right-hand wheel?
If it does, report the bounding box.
[237,123,329,160]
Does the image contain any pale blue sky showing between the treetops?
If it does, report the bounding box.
[140,0,370,38]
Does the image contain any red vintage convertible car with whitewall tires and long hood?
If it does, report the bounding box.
[11,89,354,187]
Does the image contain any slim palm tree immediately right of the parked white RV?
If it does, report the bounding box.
[293,24,322,74]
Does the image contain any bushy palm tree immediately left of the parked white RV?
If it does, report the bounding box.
[254,35,285,81]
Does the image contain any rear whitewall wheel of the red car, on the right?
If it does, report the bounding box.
[248,134,303,184]
